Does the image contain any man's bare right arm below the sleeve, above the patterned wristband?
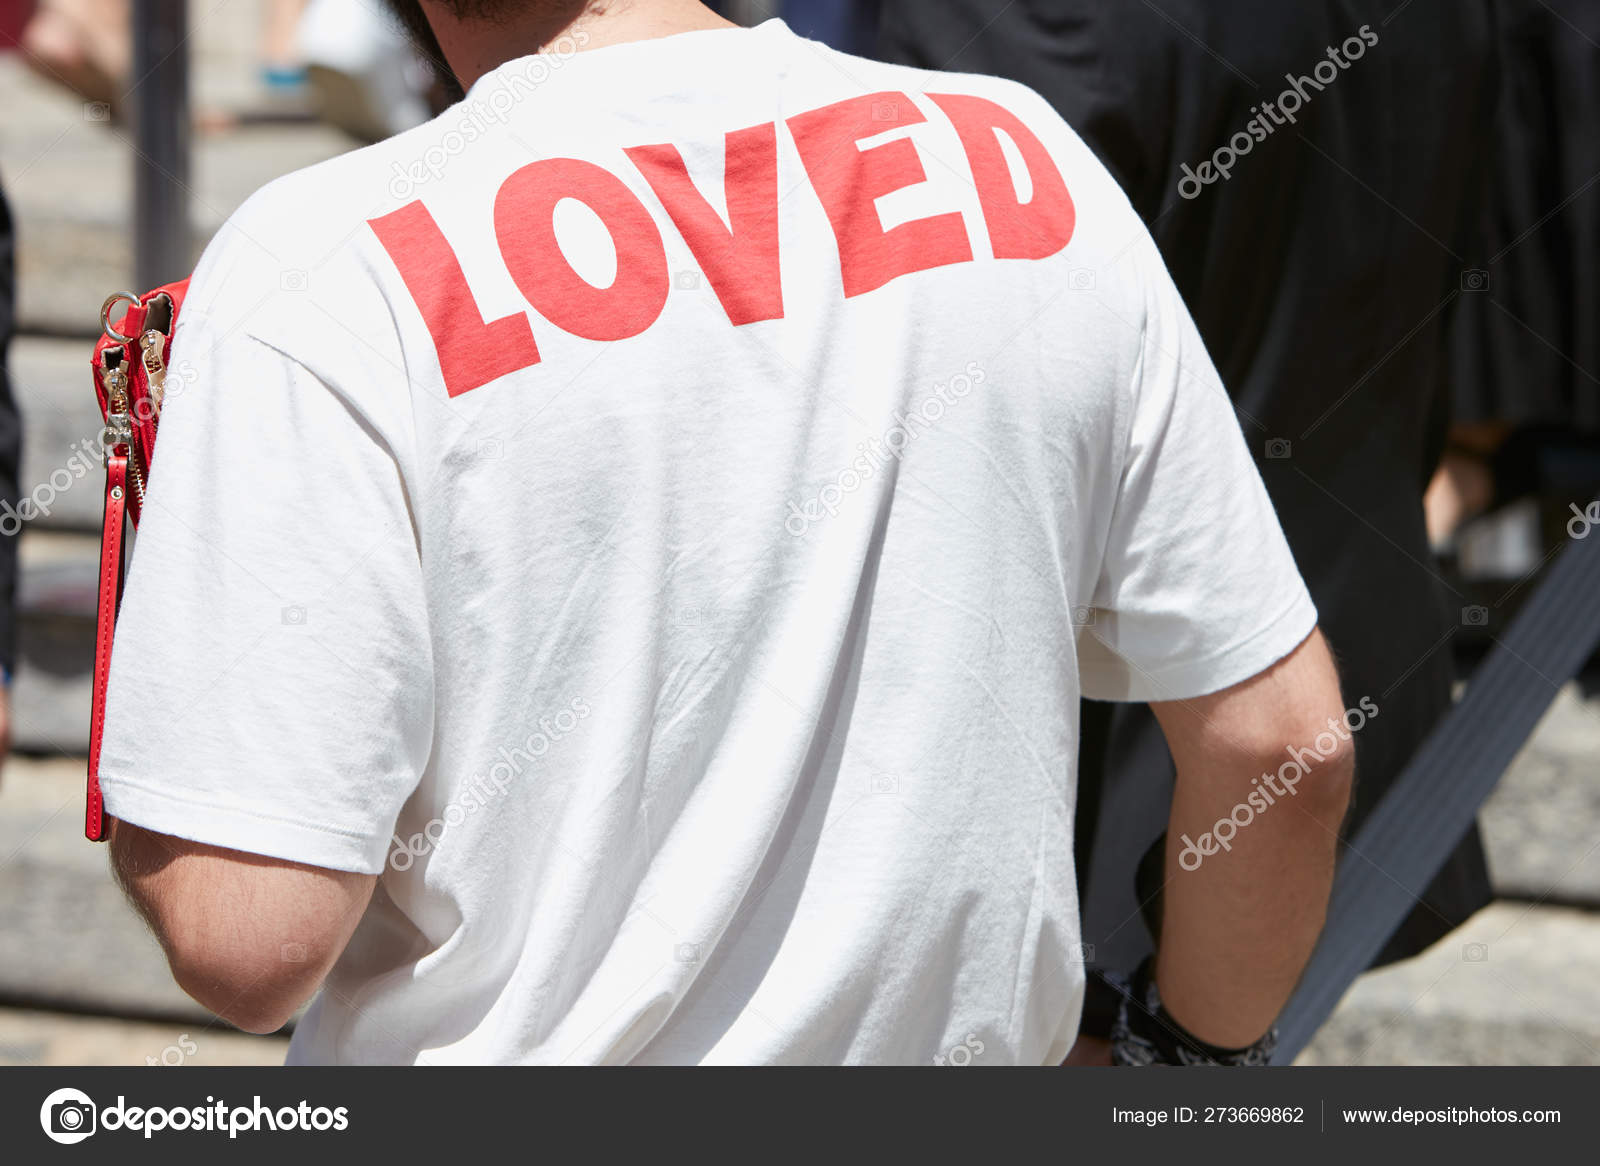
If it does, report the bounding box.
[1152,632,1355,1048]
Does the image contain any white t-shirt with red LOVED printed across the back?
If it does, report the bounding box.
[102,21,1315,1064]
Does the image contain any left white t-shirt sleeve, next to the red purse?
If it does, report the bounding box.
[101,308,434,873]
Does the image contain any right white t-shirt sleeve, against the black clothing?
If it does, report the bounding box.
[1078,237,1317,701]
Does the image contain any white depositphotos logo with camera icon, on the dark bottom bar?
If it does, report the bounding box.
[38,1089,350,1145]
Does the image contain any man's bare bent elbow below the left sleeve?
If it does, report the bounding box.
[110,822,378,1033]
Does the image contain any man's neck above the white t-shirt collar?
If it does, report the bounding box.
[422,0,738,90]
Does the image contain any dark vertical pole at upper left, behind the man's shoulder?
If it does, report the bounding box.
[128,0,194,293]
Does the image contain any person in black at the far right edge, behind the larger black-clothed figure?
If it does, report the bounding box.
[1435,0,1600,539]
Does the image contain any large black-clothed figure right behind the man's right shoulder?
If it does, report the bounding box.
[880,0,1498,1055]
